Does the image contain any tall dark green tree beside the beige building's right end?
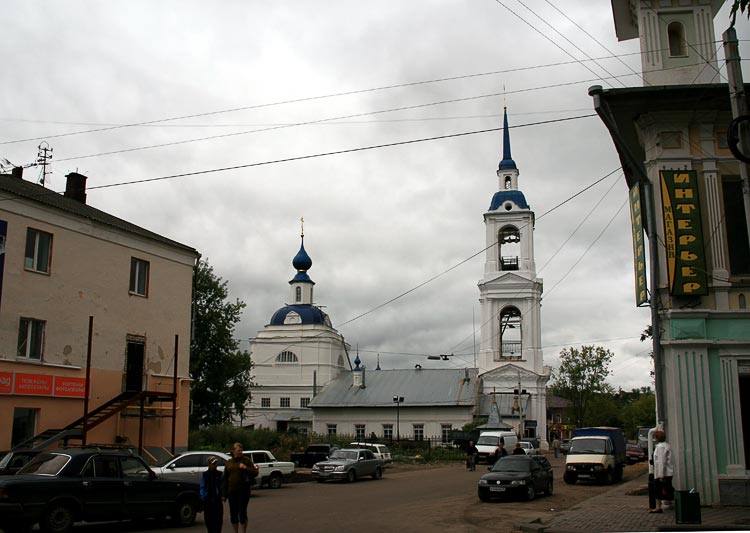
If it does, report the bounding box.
[190,259,253,429]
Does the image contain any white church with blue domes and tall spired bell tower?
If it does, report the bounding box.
[247,111,550,449]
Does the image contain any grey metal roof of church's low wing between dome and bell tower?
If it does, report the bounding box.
[310,368,477,408]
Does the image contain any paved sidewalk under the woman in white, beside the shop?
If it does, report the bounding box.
[536,475,750,533]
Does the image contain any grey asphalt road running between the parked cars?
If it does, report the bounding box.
[66,455,645,533]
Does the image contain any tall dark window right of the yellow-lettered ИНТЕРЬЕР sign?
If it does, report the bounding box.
[721,176,750,276]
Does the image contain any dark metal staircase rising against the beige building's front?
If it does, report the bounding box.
[15,391,175,450]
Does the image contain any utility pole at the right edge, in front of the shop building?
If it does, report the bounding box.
[722,26,750,238]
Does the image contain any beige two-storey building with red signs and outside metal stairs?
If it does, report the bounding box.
[0,168,198,453]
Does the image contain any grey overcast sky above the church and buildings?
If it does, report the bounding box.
[0,0,750,389]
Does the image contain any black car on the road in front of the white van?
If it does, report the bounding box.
[477,455,554,502]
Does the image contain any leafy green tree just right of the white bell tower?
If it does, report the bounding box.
[552,346,614,427]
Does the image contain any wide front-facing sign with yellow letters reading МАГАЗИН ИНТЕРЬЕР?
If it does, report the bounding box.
[659,170,708,296]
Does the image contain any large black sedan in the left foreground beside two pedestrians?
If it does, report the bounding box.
[0,448,201,533]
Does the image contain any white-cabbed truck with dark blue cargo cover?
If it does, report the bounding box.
[563,427,626,484]
